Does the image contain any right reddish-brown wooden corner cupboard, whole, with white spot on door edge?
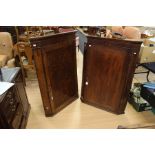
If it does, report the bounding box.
[81,37,142,114]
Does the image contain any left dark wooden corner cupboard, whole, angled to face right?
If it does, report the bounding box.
[30,31,78,116]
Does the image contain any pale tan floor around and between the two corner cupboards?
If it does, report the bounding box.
[26,52,155,129]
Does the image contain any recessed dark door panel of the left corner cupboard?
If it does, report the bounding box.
[44,44,77,109]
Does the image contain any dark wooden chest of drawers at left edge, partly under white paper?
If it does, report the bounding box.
[0,67,30,129]
